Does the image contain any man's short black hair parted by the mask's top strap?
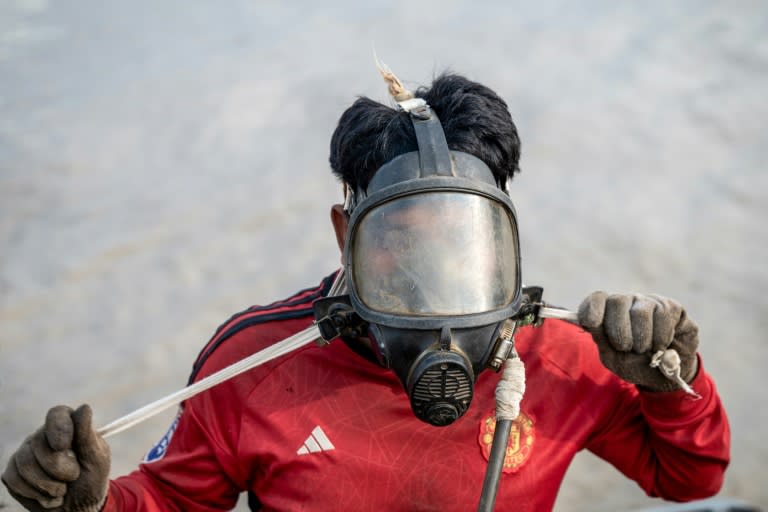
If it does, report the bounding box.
[329,74,520,195]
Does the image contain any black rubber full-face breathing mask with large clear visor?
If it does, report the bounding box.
[320,100,521,426]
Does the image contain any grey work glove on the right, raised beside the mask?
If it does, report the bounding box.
[578,292,699,391]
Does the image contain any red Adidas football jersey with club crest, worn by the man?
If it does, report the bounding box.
[104,279,730,511]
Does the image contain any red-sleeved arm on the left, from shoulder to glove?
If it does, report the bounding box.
[105,319,284,512]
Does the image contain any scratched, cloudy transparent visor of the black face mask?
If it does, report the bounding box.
[351,191,518,316]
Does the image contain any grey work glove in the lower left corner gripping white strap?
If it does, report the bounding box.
[2,405,110,512]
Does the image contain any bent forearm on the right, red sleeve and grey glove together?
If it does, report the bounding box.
[579,292,730,501]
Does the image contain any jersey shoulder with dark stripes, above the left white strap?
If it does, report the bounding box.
[189,274,335,384]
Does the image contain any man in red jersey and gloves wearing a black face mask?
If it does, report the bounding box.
[3,75,729,511]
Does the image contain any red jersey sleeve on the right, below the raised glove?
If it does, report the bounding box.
[587,360,730,501]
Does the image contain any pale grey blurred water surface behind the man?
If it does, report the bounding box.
[0,0,768,512]
